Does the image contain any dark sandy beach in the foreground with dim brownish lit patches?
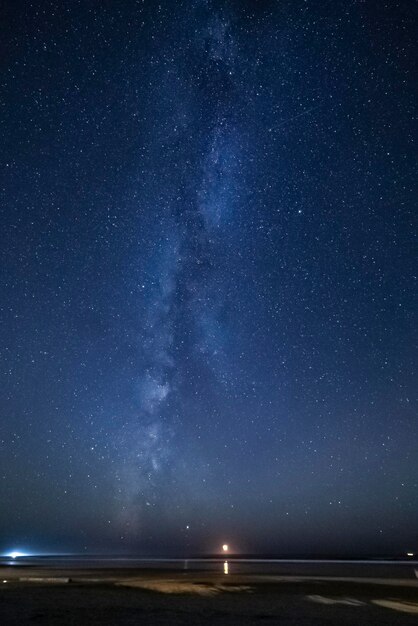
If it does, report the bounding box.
[0,568,418,626]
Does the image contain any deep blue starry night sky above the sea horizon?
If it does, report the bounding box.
[0,0,418,555]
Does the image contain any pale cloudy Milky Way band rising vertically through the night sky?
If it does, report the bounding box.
[116,3,243,535]
